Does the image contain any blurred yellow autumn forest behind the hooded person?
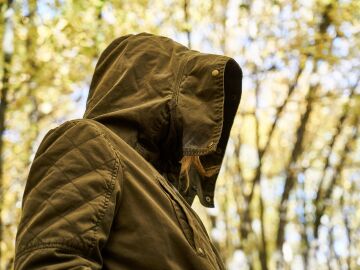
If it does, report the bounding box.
[0,0,360,270]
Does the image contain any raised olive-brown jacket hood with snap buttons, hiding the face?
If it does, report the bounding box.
[83,32,242,207]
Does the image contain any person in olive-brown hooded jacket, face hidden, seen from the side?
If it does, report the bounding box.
[14,32,242,270]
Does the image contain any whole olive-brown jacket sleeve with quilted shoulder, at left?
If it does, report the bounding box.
[14,119,122,270]
